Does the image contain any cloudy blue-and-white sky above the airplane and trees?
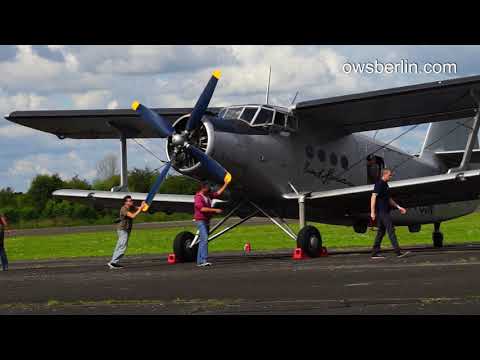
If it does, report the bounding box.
[0,45,480,191]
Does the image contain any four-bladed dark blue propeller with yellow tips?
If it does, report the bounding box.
[132,70,232,212]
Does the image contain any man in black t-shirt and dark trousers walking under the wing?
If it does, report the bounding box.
[370,169,409,259]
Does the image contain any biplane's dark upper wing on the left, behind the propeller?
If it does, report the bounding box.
[5,108,220,139]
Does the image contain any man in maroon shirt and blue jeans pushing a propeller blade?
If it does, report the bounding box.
[194,182,228,267]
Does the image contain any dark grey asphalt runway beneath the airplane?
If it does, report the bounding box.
[0,245,480,315]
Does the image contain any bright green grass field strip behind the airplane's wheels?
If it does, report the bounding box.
[5,212,480,261]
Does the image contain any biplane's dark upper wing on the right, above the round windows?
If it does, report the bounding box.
[293,76,480,133]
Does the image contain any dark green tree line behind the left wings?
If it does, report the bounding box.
[0,163,198,227]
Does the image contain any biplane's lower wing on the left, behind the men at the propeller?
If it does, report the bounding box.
[53,189,224,213]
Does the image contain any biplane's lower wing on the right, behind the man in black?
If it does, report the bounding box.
[283,170,480,214]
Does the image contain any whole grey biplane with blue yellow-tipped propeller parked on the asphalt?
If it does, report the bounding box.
[6,71,480,261]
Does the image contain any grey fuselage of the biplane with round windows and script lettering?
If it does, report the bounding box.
[194,114,478,225]
